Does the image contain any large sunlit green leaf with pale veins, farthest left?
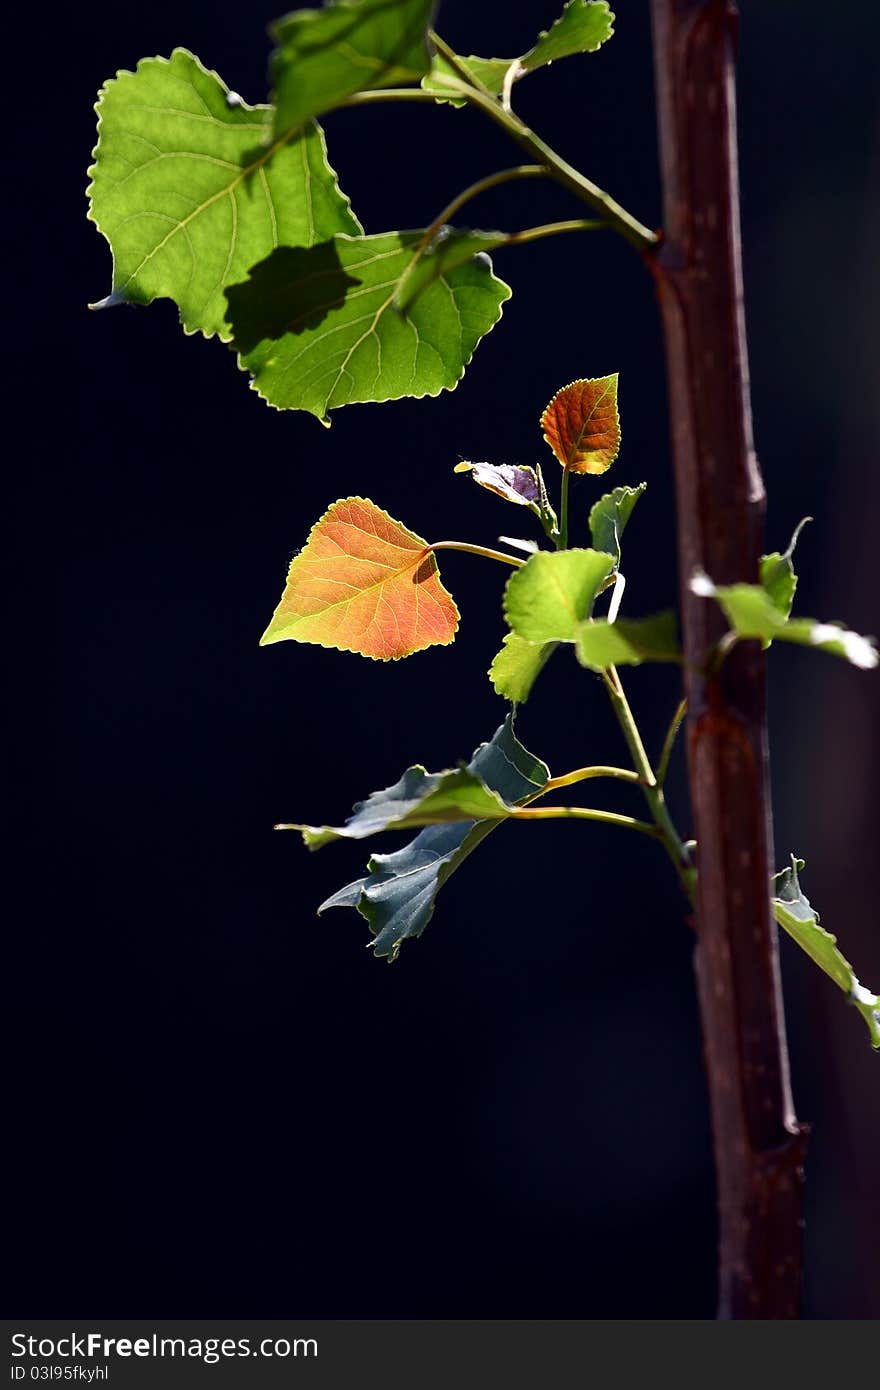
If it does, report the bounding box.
[88,49,360,339]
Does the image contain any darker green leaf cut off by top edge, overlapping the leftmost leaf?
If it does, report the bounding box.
[270,0,434,138]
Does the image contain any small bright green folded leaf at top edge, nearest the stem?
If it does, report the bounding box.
[421,0,614,106]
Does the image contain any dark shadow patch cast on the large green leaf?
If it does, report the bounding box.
[227,240,360,353]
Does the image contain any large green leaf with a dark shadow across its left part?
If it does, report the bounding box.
[227,232,510,420]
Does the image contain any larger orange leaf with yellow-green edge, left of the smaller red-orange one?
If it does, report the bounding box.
[260,498,459,662]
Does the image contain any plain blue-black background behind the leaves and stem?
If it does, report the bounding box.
[4,0,880,1318]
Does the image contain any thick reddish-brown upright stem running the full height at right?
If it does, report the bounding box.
[648,0,805,1318]
